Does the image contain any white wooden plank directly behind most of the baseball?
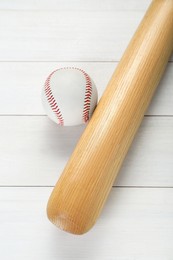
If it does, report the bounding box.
[0,62,173,115]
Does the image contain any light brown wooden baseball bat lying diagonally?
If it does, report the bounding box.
[47,0,173,234]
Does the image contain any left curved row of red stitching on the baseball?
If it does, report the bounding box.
[44,70,64,125]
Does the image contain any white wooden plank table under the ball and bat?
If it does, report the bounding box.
[0,0,173,260]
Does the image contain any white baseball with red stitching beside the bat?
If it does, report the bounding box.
[42,68,98,126]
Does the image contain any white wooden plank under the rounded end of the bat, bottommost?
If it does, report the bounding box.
[0,188,173,260]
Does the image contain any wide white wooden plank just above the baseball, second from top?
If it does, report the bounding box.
[0,10,172,61]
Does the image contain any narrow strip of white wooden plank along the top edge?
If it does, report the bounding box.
[0,0,151,12]
